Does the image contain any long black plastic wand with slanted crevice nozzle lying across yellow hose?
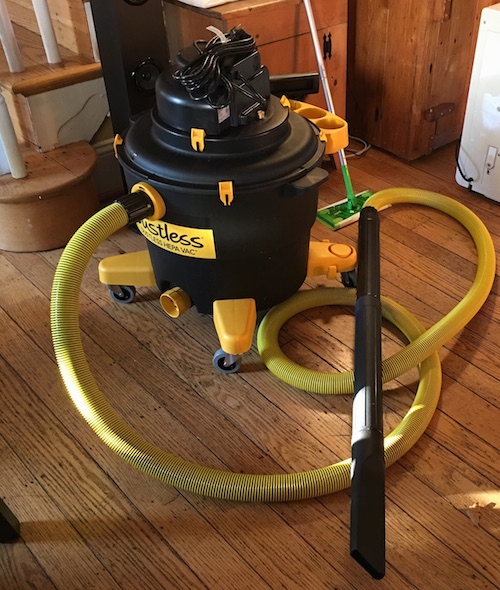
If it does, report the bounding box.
[351,207,385,580]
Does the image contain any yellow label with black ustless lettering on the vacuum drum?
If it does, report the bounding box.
[137,219,216,258]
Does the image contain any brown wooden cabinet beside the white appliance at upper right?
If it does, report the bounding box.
[347,0,498,160]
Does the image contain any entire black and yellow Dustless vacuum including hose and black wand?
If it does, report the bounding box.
[51,28,495,578]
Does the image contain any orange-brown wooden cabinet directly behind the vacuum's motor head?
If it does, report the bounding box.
[164,0,347,116]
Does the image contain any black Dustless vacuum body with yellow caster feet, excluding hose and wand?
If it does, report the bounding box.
[99,27,356,372]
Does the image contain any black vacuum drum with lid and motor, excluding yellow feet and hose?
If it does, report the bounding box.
[117,28,327,313]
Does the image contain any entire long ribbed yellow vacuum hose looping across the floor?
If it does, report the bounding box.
[51,189,495,502]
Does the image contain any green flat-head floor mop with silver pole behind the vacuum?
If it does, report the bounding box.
[304,0,371,230]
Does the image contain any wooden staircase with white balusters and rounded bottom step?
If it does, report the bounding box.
[0,0,108,251]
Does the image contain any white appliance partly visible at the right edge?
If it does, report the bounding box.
[455,4,500,201]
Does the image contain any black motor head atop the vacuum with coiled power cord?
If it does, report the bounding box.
[156,27,271,135]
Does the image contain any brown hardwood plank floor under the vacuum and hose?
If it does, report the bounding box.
[0,141,500,590]
